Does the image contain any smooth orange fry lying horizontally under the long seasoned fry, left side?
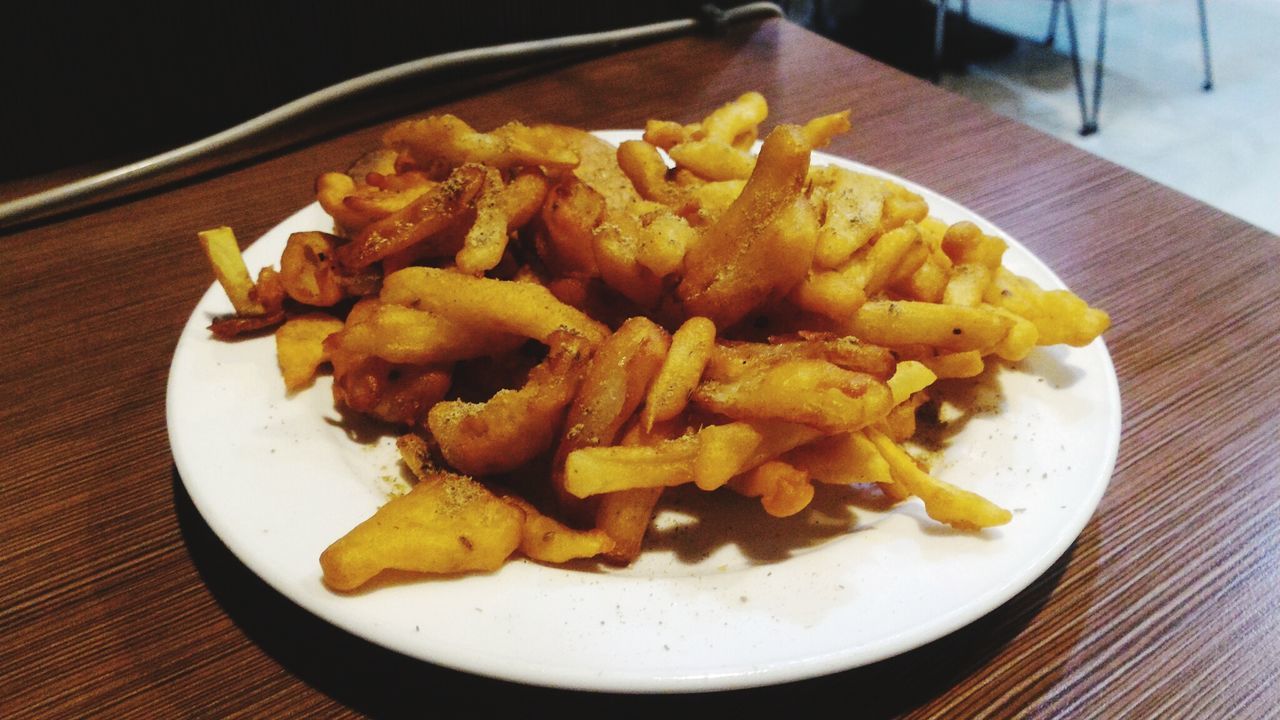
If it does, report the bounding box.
[330,301,525,365]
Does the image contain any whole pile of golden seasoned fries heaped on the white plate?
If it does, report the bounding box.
[200,92,1110,591]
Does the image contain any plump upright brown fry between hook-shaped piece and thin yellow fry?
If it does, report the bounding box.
[552,316,671,515]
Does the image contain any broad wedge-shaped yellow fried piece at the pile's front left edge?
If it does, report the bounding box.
[320,471,525,591]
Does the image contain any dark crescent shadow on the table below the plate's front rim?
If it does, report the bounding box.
[173,458,1074,717]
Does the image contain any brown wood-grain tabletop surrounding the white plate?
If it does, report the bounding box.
[0,20,1280,717]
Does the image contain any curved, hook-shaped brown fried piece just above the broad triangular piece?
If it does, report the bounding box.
[426,333,589,475]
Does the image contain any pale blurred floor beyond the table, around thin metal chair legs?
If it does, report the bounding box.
[942,0,1280,233]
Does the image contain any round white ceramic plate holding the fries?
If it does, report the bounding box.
[168,132,1120,692]
